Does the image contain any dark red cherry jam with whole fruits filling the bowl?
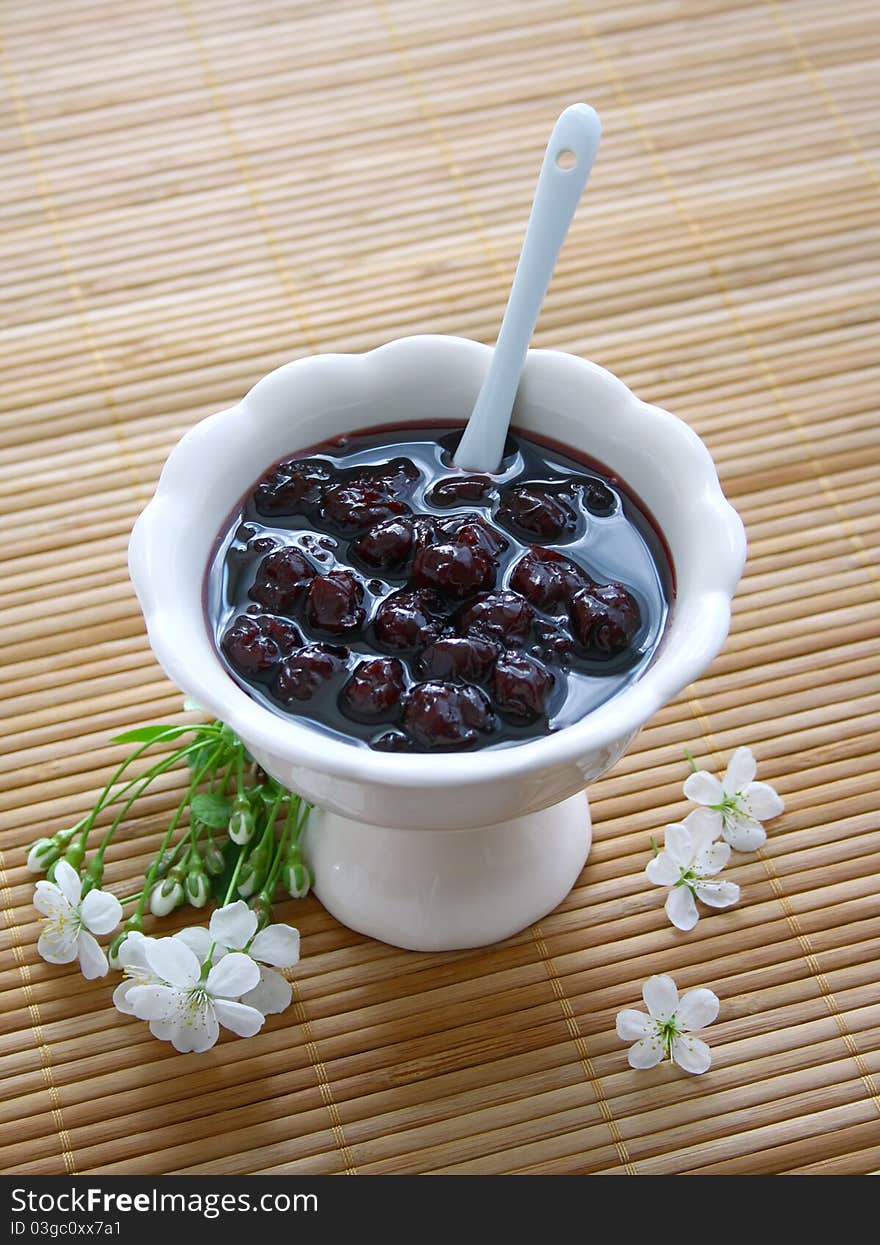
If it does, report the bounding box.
[207,427,671,752]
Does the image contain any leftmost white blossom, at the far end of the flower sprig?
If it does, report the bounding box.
[34,860,122,980]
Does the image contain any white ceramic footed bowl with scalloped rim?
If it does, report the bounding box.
[129,336,746,949]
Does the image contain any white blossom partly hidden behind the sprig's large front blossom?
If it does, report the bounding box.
[174,899,300,1016]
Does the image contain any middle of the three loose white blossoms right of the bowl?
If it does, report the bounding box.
[645,808,739,930]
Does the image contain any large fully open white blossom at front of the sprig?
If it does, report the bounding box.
[124,937,263,1053]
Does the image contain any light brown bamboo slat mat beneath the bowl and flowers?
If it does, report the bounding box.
[0,0,880,1174]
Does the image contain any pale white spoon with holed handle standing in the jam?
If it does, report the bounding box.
[454,103,601,472]
